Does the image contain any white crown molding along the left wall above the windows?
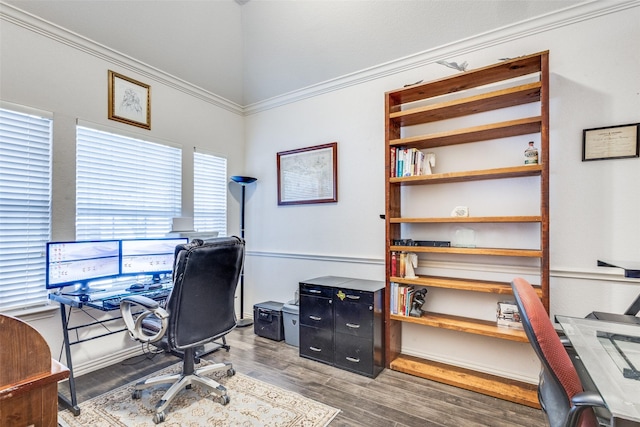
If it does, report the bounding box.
[0,1,244,115]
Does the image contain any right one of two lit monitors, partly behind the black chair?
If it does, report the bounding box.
[120,237,189,283]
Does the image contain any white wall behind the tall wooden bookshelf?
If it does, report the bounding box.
[246,2,640,382]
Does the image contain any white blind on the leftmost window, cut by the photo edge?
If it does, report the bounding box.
[0,109,52,311]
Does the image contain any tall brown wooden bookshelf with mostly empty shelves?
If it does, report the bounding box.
[385,52,549,407]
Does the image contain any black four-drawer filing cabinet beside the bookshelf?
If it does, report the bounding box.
[300,276,384,377]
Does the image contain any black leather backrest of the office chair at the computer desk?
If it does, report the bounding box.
[166,237,244,350]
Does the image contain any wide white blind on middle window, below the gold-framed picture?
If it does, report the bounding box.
[76,126,182,240]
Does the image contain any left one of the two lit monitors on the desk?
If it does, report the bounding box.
[46,240,120,289]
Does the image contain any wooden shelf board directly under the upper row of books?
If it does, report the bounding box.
[389,165,542,185]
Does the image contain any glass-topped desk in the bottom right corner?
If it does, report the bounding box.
[556,316,640,427]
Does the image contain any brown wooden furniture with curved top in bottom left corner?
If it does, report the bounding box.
[0,315,69,427]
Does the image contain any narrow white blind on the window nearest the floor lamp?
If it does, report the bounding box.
[193,152,227,236]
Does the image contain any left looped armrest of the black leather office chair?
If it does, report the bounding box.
[120,295,169,343]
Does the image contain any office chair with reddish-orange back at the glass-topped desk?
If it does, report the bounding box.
[511,278,606,427]
